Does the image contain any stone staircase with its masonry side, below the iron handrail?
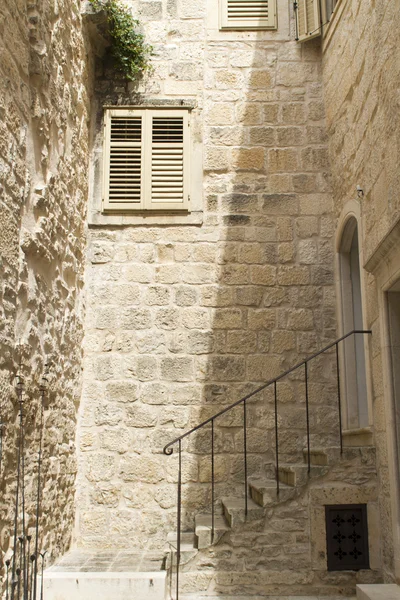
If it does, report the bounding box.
[166,440,380,599]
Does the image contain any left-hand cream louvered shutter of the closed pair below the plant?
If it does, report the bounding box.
[104,110,144,211]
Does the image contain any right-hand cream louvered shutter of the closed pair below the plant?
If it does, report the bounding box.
[145,110,189,210]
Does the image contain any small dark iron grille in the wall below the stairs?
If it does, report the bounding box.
[325,504,369,571]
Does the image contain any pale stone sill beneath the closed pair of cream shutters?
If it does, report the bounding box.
[88,210,203,227]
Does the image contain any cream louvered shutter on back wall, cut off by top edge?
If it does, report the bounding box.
[220,0,277,29]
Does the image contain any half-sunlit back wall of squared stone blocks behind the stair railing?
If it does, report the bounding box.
[78,1,338,548]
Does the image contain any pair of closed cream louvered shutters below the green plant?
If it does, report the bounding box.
[103,108,189,212]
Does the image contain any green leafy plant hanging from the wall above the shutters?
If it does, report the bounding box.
[89,0,153,81]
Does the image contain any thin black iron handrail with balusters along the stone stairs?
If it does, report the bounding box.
[163,330,372,600]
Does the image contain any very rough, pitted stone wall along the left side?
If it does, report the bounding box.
[0,0,90,564]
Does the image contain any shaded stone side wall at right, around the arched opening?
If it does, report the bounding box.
[323,0,400,580]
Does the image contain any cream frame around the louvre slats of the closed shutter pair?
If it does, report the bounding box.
[101,105,191,215]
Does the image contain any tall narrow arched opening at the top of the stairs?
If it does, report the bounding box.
[339,216,369,429]
